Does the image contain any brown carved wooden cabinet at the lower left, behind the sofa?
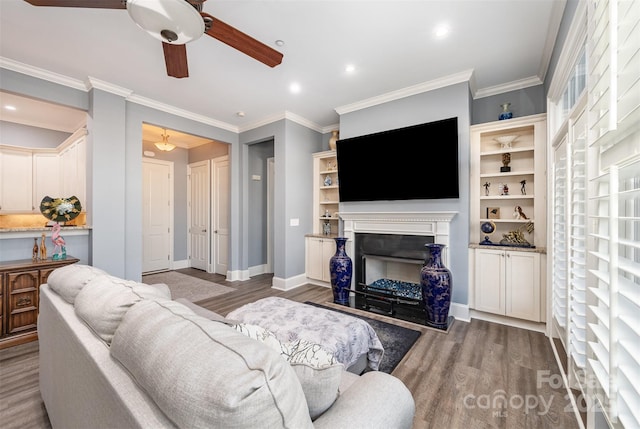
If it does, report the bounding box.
[0,254,78,349]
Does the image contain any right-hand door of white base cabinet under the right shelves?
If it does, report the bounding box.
[505,251,540,322]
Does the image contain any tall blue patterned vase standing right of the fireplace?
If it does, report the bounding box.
[420,243,451,330]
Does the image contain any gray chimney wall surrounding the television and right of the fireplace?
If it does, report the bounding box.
[340,83,471,304]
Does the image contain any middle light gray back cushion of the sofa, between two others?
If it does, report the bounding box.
[75,275,171,344]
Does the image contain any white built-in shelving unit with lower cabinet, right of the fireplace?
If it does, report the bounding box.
[469,114,547,326]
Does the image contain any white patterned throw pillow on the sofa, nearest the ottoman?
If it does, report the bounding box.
[233,323,344,420]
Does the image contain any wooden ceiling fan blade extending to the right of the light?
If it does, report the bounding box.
[200,12,283,67]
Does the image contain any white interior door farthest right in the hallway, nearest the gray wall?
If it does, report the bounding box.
[211,156,230,276]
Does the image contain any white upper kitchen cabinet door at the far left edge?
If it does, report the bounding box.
[0,149,35,213]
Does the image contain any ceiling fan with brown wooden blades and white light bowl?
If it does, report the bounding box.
[24,0,283,78]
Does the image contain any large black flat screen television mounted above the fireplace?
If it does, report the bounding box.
[336,117,459,202]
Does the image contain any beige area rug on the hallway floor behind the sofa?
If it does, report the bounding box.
[142,271,235,302]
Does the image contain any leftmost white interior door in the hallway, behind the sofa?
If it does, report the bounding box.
[142,159,173,272]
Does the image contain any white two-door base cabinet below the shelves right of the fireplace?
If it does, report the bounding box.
[474,248,541,322]
